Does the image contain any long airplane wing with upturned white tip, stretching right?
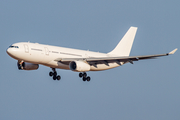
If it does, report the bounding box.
[55,48,177,65]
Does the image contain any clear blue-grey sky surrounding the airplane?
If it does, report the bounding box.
[0,0,180,120]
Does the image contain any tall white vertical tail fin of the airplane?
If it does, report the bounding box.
[108,27,137,56]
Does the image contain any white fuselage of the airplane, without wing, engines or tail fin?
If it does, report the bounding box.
[7,42,123,71]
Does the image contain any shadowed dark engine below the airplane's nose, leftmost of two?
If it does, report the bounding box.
[17,62,39,70]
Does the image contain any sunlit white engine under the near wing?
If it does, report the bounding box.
[69,61,90,72]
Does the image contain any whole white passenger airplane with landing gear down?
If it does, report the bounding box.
[6,27,177,81]
